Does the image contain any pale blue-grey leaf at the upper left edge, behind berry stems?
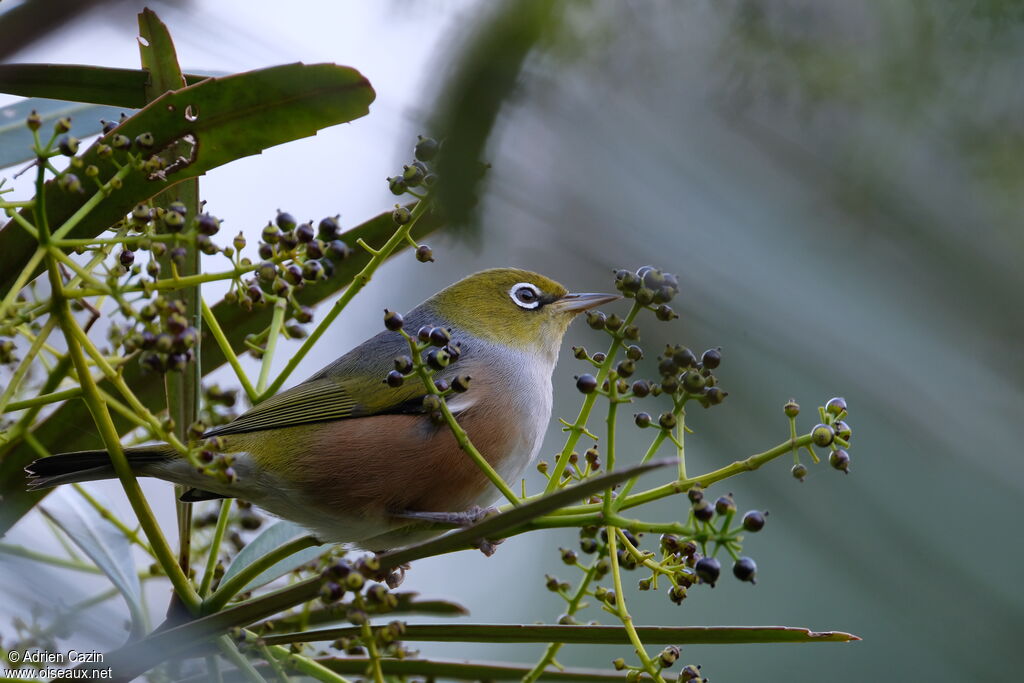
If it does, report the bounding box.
[0,97,131,168]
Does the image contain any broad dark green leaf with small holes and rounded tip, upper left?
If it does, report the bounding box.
[0,63,375,291]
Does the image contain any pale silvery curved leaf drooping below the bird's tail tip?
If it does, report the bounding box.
[40,486,145,635]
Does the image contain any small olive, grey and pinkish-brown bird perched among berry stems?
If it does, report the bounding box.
[26,268,618,551]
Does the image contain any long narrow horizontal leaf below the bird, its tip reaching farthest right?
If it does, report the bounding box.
[264,624,860,645]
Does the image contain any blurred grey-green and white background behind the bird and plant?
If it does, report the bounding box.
[0,0,1024,681]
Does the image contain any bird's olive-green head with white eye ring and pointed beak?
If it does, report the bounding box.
[426,268,618,354]
